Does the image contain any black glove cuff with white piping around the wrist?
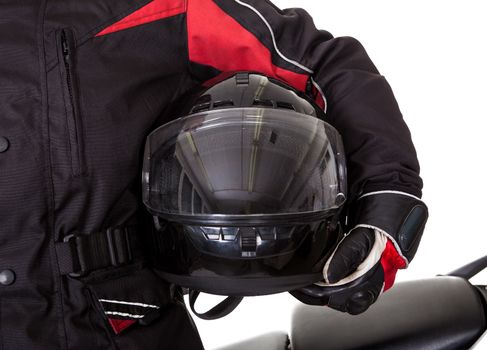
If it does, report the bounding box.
[350,191,428,263]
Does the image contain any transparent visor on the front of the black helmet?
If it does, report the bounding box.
[143,108,346,226]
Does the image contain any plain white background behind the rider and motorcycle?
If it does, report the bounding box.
[190,0,487,349]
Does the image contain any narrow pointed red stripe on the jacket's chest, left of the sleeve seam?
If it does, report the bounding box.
[96,0,186,36]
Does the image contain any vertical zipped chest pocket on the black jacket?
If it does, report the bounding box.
[57,28,86,176]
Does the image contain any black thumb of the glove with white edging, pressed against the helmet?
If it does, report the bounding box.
[323,227,375,284]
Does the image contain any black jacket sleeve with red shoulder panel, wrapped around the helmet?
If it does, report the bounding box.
[187,0,422,200]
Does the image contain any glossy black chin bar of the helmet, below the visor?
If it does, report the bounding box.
[153,217,340,296]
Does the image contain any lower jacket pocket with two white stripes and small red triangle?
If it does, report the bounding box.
[86,267,203,350]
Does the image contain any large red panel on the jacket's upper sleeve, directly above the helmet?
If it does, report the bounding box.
[187,0,308,91]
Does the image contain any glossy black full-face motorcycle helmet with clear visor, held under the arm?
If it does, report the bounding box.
[143,73,346,296]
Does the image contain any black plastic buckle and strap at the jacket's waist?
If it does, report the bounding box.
[55,226,142,277]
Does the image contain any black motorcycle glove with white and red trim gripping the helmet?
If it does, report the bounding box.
[291,191,428,314]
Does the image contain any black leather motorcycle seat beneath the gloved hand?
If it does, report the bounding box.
[290,276,486,350]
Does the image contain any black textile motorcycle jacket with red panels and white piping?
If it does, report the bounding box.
[0,0,422,350]
